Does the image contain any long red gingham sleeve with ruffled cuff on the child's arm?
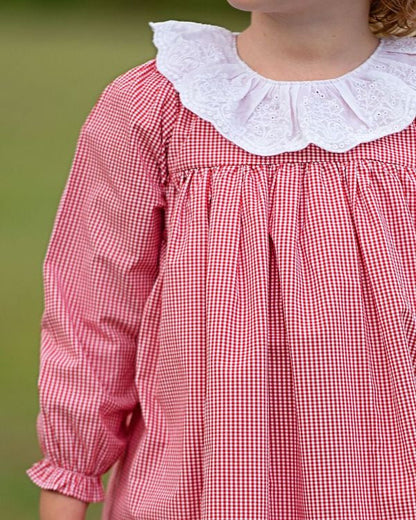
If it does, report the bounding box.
[26,64,171,502]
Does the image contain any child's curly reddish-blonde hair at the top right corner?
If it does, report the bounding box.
[369,0,416,37]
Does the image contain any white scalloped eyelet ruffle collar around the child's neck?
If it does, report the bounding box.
[149,20,416,156]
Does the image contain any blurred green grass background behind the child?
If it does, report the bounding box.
[0,4,249,520]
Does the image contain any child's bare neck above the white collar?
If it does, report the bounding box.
[237,7,379,81]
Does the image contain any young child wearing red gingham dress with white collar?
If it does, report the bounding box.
[27,0,416,520]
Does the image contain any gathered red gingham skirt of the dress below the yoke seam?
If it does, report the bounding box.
[103,159,416,520]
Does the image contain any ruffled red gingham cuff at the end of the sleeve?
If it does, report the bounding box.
[26,458,105,503]
